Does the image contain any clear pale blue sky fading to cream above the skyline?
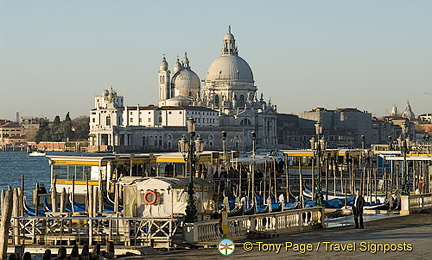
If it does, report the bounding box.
[0,0,432,120]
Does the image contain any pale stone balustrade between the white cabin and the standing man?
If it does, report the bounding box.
[183,207,325,243]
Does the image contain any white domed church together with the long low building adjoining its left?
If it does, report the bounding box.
[89,28,277,151]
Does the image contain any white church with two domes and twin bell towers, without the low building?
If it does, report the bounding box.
[158,28,277,149]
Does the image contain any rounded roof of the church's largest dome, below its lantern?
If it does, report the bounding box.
[206,55,254,83]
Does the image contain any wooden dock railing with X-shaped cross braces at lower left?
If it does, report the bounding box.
[9,216,182,248]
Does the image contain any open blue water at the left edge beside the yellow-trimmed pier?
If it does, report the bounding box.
[0,151,50,200]
